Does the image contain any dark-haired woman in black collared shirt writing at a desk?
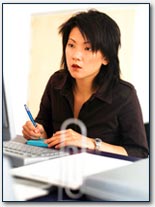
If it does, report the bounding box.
[23,10,148,158]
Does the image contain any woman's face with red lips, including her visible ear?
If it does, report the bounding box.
[65,27,107,80]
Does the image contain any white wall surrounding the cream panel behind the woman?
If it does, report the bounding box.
[3,4,149,137]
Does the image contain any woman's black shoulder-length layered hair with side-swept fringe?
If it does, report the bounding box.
[59,10,121,83]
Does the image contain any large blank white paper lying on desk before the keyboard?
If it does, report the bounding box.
[11,152,132,189]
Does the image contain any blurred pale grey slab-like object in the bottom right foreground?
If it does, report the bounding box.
[80,158,149,201]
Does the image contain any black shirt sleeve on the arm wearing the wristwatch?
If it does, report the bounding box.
[119,87,148,158]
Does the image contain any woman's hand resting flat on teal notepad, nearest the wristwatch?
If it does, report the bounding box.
[45,129,94,149]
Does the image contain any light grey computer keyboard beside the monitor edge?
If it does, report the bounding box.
[3,141,69,167]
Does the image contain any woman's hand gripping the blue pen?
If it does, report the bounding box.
[22,121,47,139]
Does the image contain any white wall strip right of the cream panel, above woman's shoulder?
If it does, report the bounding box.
[132,7,150,126]
